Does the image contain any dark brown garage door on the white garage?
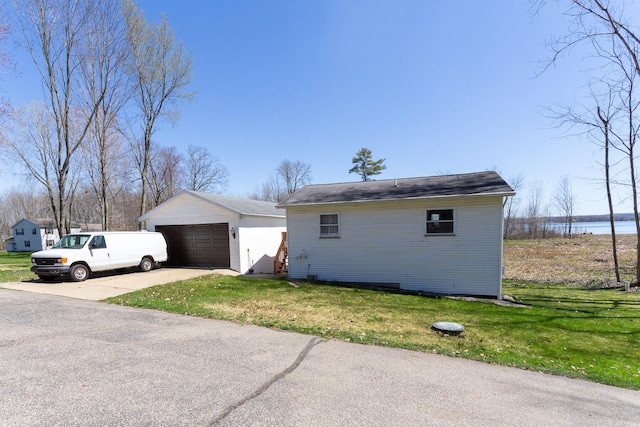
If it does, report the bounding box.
[156,222,231,268]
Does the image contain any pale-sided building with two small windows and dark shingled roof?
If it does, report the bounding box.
[278,172,515,298]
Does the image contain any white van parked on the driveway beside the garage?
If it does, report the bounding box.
[31,231,167,282]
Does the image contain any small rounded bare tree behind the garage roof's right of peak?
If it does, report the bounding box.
[185,145,229,192]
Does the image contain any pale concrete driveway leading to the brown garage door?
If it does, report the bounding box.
[0,267,239,301]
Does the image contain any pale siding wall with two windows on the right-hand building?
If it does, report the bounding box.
[287,197,502,297]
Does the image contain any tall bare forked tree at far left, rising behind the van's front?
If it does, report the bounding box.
[14,0,116,235]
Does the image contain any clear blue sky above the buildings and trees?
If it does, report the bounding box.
[4,0,631,214]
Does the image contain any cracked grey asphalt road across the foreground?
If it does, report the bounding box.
[0,289,640,426]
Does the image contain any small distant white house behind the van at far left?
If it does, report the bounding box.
[5,218,80,252]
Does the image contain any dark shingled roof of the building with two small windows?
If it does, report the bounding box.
[278,171,515,208]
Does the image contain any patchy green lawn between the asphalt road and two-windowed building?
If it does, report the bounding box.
[108,275,640,390]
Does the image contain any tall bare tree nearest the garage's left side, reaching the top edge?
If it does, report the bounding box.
[124,0,195,228]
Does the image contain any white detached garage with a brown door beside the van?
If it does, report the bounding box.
[138,190,286,273]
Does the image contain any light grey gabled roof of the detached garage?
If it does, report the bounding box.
[138,190,285,221]
